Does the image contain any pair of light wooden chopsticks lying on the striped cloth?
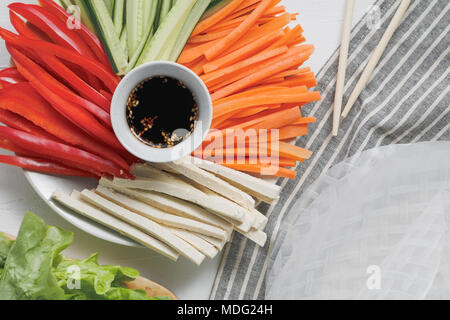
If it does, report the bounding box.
[333,0,411,136]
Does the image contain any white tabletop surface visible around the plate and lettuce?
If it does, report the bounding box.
[0,0,374,299]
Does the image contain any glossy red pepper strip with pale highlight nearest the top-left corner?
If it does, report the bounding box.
[8,2,101,88]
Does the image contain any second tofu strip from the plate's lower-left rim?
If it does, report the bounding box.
[81,190,205,265]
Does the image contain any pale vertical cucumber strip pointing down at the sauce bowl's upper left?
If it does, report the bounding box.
[126,0,145,57]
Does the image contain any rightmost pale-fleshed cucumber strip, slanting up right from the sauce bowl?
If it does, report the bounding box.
[168,0,211,62]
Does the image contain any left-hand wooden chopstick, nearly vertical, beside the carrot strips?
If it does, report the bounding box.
[333,0,355,136]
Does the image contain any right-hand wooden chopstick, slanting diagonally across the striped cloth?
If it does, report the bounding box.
[341,0,411,120]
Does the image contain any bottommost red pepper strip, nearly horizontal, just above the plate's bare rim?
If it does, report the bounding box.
[0,155,95,177]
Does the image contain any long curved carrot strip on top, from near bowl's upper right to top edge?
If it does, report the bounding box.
[205,0,273,61]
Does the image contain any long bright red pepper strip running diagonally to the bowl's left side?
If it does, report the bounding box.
[8,47,124,151]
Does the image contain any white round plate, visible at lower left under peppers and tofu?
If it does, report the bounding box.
[24,171,141,247]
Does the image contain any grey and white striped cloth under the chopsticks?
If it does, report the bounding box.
[211,0,450,300]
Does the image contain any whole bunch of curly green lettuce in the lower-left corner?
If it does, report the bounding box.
[0,212,169,300]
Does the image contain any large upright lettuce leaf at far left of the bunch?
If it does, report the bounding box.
[0,212,73,300]
